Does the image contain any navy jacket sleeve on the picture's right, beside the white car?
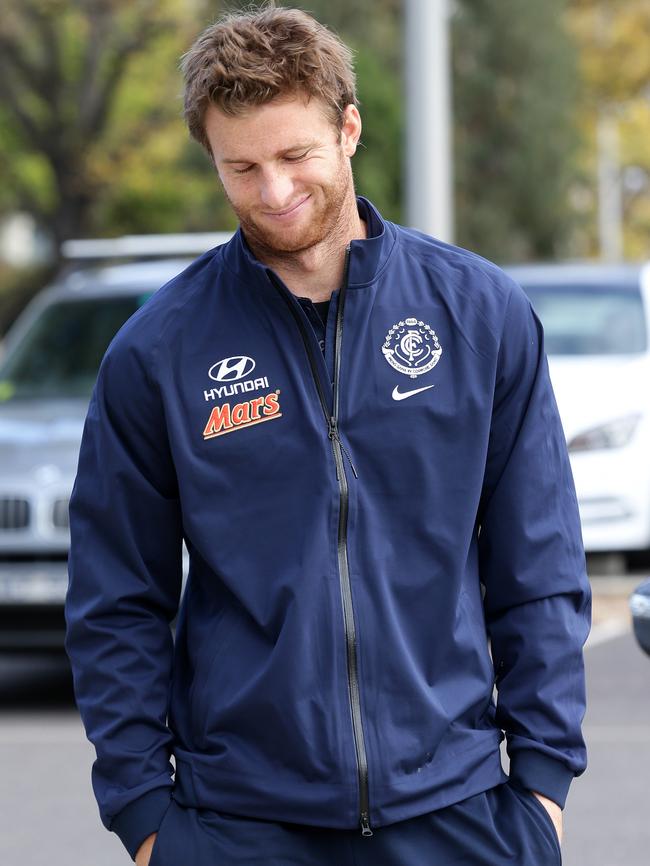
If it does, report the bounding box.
[479,284,591,807]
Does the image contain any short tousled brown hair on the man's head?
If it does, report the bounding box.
[181,6,357,153]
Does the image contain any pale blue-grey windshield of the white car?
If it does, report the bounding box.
[523,284,647,355]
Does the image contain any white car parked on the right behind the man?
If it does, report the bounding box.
[506,264,650,553]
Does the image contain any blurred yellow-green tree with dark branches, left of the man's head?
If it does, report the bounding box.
[0,0,232,249]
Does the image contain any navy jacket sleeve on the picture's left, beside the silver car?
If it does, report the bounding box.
[66,335,182,858]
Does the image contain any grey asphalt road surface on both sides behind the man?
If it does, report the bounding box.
[0,580,650,866]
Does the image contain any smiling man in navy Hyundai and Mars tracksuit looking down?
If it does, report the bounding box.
[67,8,590,866]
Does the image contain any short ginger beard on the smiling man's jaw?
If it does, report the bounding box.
[222,147,354,257]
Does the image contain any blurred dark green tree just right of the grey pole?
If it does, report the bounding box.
[453,0,578,261]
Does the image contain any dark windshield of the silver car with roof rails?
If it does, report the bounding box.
[0,293,151,402]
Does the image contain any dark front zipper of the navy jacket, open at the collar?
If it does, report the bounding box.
[267,246,373,836]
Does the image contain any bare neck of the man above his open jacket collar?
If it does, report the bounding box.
[249,190,367,302]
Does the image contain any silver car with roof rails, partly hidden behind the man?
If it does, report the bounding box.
[0,253,197,650]
